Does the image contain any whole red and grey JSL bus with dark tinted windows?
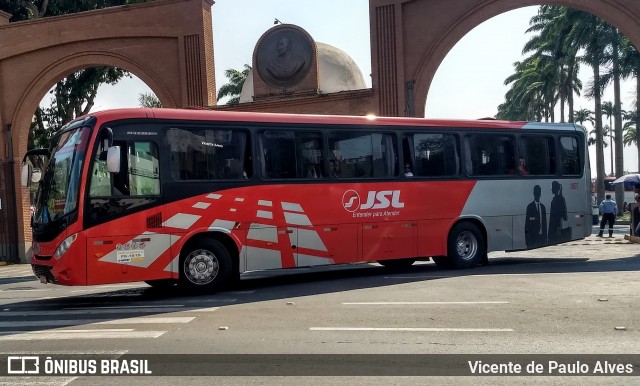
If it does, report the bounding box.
[22,109,591,291]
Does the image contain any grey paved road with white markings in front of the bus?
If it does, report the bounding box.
[0,226,640,385]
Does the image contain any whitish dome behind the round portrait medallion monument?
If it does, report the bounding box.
[240,42,367,103]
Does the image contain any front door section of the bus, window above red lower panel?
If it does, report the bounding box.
[85,128,171,284]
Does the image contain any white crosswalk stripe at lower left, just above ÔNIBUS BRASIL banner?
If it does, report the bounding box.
[0,329,167,341]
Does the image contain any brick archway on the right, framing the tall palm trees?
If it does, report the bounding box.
[369,0,640,117]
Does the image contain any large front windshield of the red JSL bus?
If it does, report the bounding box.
[33,127,91,224]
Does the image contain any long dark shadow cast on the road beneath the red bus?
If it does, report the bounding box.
[0,255,640,341]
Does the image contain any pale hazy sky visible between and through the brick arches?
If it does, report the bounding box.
[82,0,637,172]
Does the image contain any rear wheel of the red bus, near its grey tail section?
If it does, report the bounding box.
[433,222,487,269]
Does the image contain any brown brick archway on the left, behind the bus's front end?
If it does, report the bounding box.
[0,0,216,261]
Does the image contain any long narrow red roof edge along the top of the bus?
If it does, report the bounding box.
[85,108,582,131]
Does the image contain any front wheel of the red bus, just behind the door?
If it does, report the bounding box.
[180,239,233,293]
